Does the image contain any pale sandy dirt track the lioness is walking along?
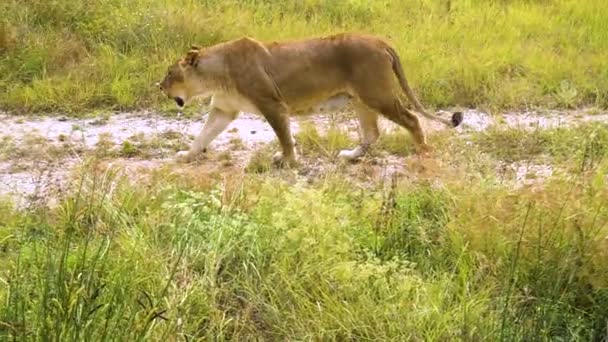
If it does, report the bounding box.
[0,110,608,206]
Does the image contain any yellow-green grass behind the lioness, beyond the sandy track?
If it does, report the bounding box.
[0,0,608,114]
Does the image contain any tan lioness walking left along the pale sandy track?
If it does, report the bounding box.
[159,33,463,165]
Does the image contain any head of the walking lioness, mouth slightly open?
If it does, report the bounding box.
[158,46,222,108]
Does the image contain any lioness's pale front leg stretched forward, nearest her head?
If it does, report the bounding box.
[175,108,238,163]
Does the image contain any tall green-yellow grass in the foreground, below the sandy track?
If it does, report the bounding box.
[0,155,608,341]
